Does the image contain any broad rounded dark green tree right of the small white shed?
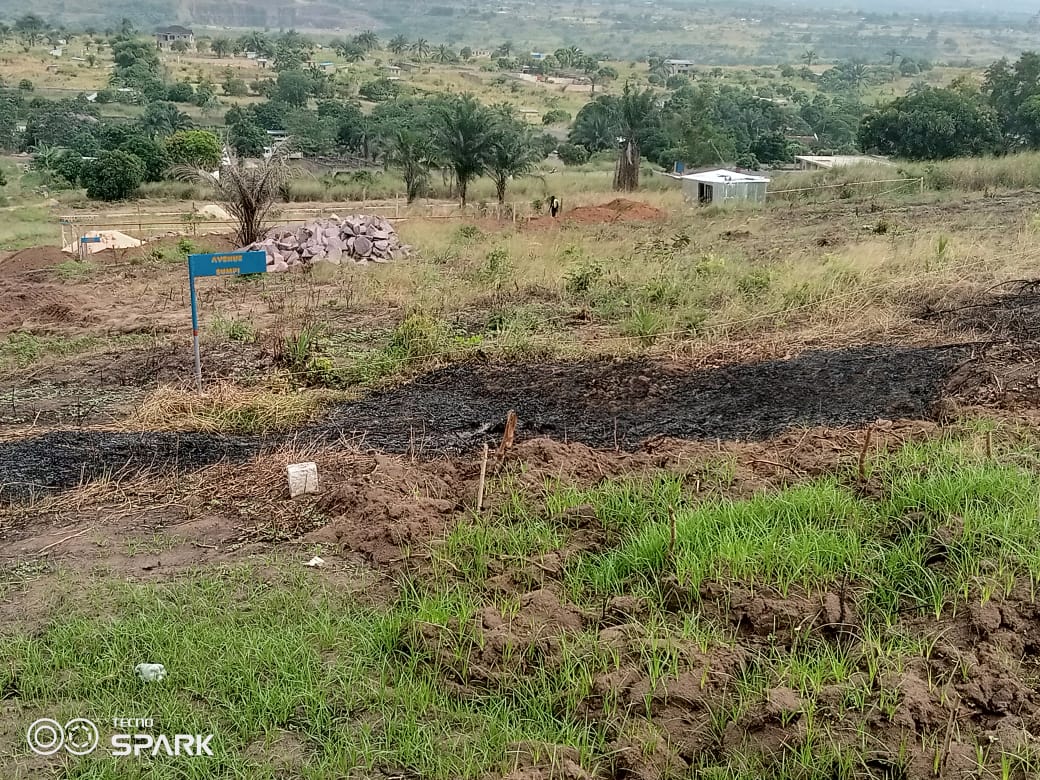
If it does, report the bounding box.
[858,87,1003,160]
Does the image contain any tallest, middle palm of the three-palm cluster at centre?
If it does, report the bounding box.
[434,95,494,208]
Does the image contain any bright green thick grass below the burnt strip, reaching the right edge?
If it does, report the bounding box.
[550,441,1040,617]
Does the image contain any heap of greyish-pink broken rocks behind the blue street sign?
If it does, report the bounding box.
[243,214,412,272]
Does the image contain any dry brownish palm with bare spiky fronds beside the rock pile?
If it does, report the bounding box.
[178,142,294,246]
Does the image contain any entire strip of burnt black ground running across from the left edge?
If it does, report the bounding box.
[0,346,967,500]
